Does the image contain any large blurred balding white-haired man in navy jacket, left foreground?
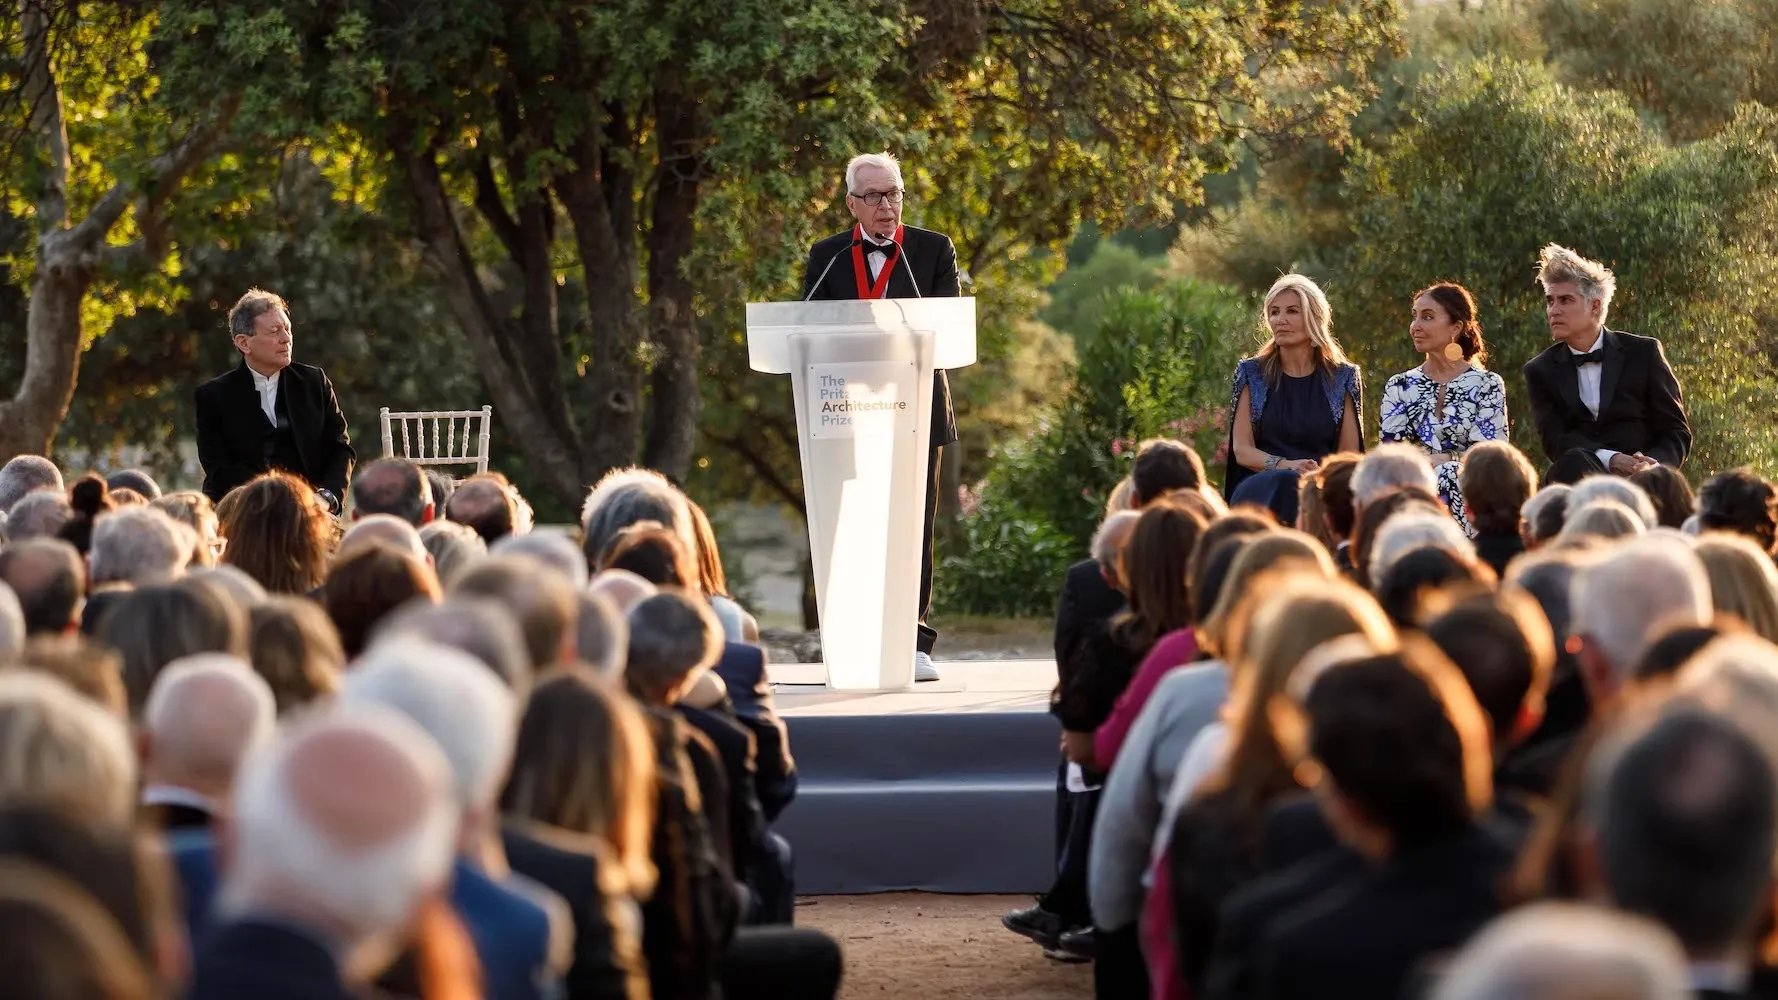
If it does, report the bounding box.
[188,706,459,1000]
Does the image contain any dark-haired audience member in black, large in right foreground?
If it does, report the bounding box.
[1205,639,1511,998]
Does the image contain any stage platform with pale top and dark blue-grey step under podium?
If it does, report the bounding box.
[770,660,1060,895]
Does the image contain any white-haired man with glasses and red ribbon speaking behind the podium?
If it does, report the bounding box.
[802,153,962,680]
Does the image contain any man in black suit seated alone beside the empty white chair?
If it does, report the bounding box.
[196,288,356,514]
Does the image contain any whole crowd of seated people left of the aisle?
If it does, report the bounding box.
[0,456,841,1000]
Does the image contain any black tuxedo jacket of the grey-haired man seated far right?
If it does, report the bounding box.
[1526,329,1691,468]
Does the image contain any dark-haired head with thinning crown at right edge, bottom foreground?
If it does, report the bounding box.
[1598,708,1778,956]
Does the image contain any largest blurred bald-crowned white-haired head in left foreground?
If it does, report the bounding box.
[217,705,459,952]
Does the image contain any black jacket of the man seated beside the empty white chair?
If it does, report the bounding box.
[196,363,357,502]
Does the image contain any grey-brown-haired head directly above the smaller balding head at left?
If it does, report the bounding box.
[100,587,247,715]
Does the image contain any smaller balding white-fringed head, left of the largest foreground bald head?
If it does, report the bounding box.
[142,653,277,792]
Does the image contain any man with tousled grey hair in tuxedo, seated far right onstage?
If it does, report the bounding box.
[1526,244,1691,482]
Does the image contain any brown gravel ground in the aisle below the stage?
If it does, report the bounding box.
[797,893,1093,1000]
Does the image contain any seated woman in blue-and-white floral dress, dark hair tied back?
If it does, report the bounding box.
[1380,283,1506,528]
